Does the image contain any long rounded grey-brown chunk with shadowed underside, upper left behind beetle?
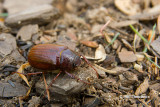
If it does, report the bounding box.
[5,4,59,28]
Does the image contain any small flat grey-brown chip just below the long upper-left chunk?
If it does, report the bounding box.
[17,25,39,41]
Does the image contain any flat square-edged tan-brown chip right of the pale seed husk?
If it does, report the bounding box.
[118,51,137,62]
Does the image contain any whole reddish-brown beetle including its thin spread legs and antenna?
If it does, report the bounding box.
[17,44,98,100]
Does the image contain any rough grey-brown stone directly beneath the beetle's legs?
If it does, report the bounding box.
[35,67,98,103]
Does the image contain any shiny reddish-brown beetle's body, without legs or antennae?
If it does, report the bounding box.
[28,44,81,71]
